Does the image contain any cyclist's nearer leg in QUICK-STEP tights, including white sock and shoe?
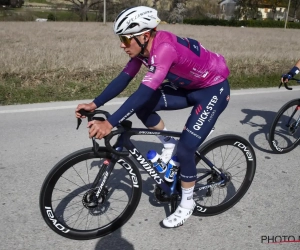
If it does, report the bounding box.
[163,80,230,227]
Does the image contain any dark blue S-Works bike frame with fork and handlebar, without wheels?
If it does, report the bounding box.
[77,110,227,203]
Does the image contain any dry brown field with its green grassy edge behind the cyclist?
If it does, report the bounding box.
[0,21,300,105]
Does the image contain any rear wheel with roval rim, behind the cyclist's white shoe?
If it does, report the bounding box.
[193,135,256,216]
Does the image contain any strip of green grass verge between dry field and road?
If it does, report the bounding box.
[0,68,288,105]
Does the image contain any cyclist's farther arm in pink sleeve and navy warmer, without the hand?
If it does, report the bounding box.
[93,59,142,108]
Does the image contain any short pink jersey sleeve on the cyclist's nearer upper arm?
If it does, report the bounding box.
[142,43,178,90]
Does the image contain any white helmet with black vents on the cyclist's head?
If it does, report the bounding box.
[114,6,160,35]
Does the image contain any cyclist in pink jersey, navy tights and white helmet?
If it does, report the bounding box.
[75,6,230,227]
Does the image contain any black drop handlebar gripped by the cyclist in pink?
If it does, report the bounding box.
[76,109,132,156]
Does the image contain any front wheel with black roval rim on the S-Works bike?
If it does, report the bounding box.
[40,148,142,240]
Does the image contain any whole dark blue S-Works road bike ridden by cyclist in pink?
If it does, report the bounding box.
[39,110,256,240]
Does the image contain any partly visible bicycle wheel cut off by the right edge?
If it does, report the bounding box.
[268,99,300,154]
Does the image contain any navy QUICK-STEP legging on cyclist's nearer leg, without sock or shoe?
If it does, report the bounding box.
[177,80,230,182]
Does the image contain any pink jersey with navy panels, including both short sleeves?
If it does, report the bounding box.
[123,31,229,90]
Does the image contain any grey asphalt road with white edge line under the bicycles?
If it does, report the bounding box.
[0,87,300,250]
